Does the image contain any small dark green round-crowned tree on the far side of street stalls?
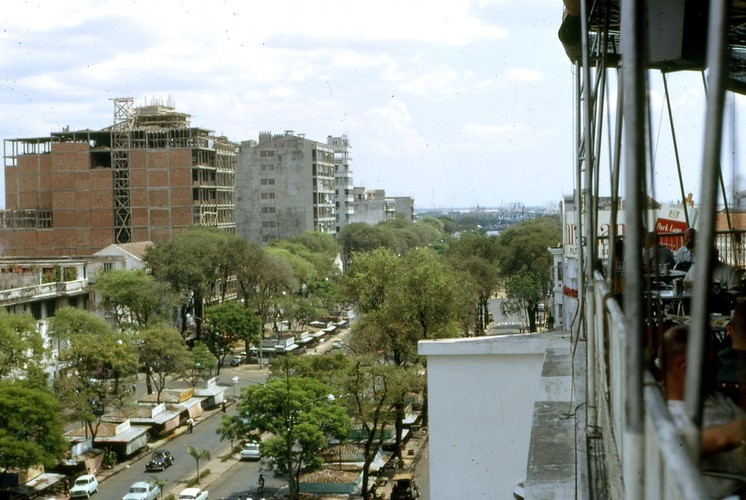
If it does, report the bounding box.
[205,302,261,373]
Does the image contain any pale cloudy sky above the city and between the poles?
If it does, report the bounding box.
[0,0,742,208]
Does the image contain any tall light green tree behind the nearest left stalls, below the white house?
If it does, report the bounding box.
[49,307,138,439]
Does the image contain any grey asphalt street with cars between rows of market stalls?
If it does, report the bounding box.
[99,365,267,499]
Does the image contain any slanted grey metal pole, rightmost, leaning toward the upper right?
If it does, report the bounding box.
[684,0,728,457]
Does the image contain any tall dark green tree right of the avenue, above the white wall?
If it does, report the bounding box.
[498,217,562,332]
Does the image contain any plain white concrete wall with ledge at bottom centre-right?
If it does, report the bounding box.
[419,333,567,499]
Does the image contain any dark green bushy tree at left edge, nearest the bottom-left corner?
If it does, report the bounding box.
[0,381,68,471]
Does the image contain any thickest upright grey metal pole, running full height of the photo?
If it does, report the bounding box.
[621,0,646,500]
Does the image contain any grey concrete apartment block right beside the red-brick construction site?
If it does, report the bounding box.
[236,130,337,243]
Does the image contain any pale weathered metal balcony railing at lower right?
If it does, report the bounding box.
[587,272,707,500]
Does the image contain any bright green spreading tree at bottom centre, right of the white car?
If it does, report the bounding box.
[238,372,349,499]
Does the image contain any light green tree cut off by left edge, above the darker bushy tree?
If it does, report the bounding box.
[0,309,45,379]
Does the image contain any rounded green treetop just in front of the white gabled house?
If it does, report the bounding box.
[94,269,170,329]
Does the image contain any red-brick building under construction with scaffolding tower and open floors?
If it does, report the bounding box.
[0,98,238,256]
